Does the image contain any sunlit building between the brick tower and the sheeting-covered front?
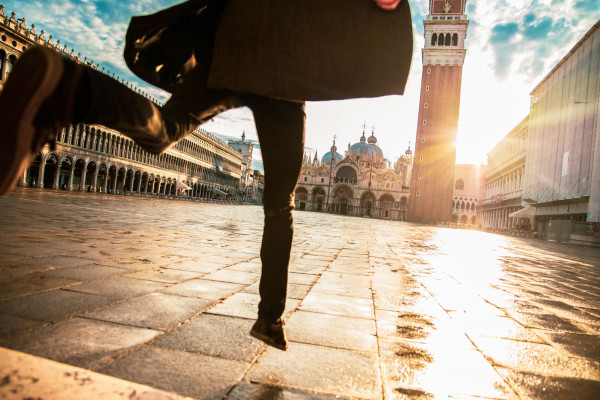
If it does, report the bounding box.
[478,116,533,230]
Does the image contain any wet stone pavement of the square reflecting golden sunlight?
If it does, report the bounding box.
[0,189,600,399]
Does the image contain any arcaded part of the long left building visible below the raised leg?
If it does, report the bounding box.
[19,124,241,200]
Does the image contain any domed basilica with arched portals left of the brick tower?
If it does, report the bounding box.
[295,129,413,221]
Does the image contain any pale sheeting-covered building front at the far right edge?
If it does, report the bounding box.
[523,21,600,234]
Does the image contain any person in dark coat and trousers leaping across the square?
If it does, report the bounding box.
[0,0,412,350]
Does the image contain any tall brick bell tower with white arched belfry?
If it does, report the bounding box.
[408,0,469,223]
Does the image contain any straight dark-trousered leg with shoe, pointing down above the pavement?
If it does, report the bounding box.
[244,96,305,350]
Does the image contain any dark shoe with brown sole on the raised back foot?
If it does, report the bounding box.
[0,46,81,196]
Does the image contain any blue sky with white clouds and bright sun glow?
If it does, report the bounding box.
[0,0,600,169]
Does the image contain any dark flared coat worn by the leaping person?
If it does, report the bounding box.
[125,0,413,101]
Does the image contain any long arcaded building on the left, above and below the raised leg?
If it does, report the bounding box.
[0,5,244,201]
